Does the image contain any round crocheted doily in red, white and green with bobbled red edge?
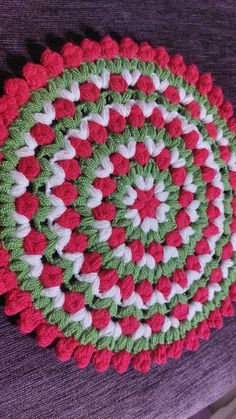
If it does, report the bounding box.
[0,36,236,372]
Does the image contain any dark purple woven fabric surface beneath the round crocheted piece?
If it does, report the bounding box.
[0,0,236,419]
